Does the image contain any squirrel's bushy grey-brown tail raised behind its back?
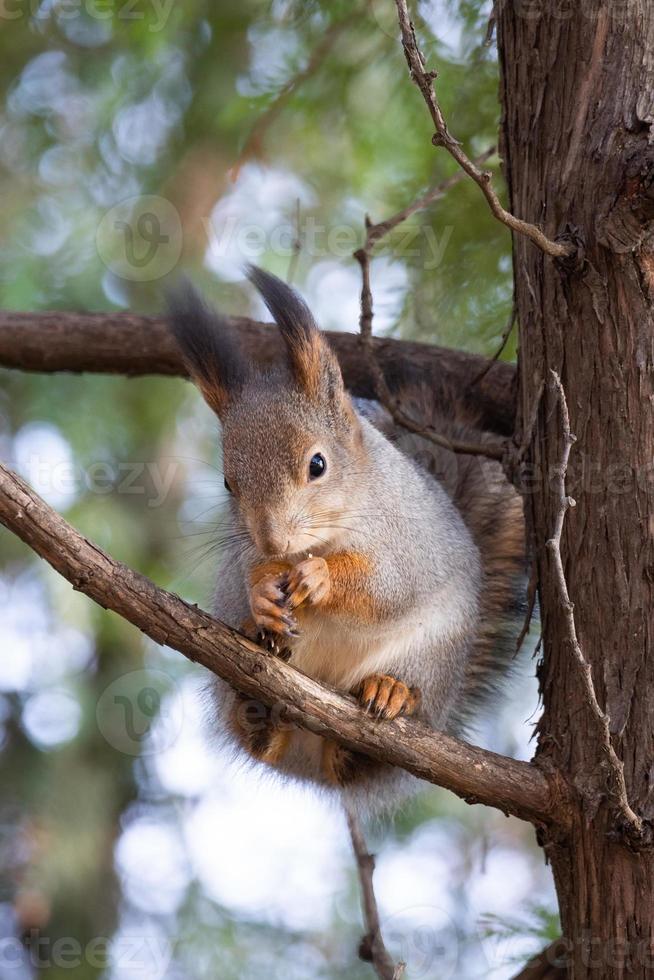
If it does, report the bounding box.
[358,384,527,731]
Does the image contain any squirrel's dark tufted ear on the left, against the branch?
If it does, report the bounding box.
[167,280,249,417]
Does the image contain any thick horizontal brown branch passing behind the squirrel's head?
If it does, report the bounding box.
[0,312,515,436]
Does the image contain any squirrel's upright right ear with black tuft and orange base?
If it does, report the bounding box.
[247,265,349,412]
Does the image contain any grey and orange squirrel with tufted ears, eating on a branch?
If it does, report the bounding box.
[170,266,526,813]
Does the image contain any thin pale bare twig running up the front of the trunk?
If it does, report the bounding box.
[547,371,645,841]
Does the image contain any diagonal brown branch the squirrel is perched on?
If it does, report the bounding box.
[0,463,567,825]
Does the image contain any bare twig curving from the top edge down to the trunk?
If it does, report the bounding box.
[395,0,575,258]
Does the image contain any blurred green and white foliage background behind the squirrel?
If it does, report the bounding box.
[0,0,557,980]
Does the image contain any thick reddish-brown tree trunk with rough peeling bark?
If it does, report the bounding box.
[496,0,654,980]
